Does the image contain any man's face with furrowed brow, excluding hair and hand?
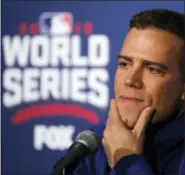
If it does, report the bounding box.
[114,28,184,128]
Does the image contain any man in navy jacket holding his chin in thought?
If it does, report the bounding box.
[53,9,185,175]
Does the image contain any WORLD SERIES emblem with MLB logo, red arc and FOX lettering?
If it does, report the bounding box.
[2,12,110,150]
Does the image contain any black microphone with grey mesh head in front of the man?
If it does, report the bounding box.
[52,130,99,175]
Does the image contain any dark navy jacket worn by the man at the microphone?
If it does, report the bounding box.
[73,112,185,175]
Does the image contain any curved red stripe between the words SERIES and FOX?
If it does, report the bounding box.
[12,104,99,124]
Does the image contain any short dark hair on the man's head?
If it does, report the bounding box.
[130,9,185,81]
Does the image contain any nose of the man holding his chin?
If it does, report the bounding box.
[124,69,143,89]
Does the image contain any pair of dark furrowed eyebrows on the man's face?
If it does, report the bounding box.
[118,55,168,71]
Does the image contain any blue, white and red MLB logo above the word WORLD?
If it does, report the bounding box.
[39,12,73,35]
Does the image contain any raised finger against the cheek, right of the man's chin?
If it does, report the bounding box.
[133,107,156,136]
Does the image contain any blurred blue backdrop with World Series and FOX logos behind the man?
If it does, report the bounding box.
[1,0,184,174]
